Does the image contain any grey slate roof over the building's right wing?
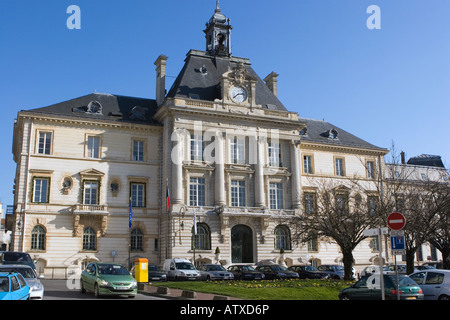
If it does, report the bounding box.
[300,118,387,152]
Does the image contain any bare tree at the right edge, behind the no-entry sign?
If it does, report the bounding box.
[379,147,448,273]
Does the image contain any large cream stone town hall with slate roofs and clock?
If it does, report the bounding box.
[7,5,442,278]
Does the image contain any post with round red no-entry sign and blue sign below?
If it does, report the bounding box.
[388,212,406,300]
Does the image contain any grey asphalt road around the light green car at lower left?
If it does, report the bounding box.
[41,279,165,301]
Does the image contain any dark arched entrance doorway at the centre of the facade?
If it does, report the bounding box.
[231,224,254,263]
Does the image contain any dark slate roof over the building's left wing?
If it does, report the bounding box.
[27,93,158,124]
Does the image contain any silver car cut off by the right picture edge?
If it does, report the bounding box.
[409,269,450,300]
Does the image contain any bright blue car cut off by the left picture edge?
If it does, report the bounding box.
[0,272,30,300]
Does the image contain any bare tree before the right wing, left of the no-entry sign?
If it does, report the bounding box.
[291,178,380,280]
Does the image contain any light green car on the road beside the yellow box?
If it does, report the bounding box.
[80,262,137,298]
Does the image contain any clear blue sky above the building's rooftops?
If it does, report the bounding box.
[0,0,450,208]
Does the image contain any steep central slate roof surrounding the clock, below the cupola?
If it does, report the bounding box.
[167,50,287,111]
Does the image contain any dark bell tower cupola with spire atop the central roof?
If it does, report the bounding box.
[203,0,233,56]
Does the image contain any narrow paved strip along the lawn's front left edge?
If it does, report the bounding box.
[138,283,242,300]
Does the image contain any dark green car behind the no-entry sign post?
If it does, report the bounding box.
[339,273,424,300]
